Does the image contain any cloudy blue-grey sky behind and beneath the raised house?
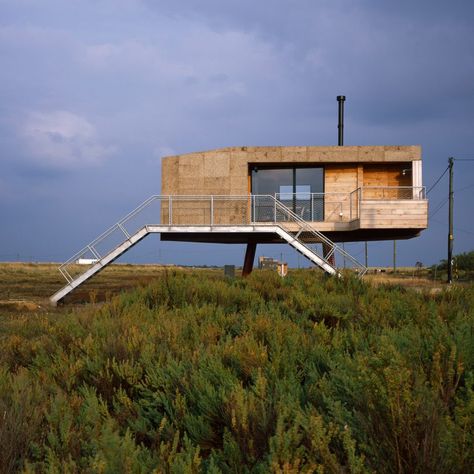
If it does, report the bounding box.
[0,0,474,265]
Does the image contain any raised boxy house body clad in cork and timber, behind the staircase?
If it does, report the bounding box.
[162,146,428,242]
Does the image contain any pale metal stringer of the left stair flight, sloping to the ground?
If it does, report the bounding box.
[49,226,150,306]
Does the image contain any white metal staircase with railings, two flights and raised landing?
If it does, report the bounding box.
[50,195,366,305]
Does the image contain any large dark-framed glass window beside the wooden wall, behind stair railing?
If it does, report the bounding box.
[251,165,324,221]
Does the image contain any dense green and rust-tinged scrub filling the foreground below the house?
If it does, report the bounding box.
[0,270,474,473]
